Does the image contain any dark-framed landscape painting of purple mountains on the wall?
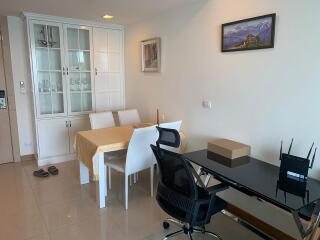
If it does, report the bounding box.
[221,13,276,52]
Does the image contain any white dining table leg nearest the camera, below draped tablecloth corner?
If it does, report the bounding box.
[94,152,107,208]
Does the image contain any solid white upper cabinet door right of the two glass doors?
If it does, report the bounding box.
[93,28,124,112]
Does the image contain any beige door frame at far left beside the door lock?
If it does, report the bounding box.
[0,16,21,162]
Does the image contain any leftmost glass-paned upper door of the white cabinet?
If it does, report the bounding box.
[31,22,65,116]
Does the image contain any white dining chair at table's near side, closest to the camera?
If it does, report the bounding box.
[105,126,158,209]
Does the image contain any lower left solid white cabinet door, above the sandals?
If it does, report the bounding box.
[37,118,69,158]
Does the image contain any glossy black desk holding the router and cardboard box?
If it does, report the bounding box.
[184,150,320,239]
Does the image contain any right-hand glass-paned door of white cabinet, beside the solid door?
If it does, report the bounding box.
[65,26,93,114]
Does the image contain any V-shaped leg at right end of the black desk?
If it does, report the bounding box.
[292,201,320,240]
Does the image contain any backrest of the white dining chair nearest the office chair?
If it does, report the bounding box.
[126,126,158,174]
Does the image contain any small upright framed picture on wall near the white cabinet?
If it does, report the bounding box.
[141,37,161,72]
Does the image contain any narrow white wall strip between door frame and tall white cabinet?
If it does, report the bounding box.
[8,16,35,156]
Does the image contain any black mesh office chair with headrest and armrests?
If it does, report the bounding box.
[151,127,227,240]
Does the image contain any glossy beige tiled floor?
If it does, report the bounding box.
[0,161,259,240]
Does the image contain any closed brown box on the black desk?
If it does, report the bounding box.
[208,139,251,160]
